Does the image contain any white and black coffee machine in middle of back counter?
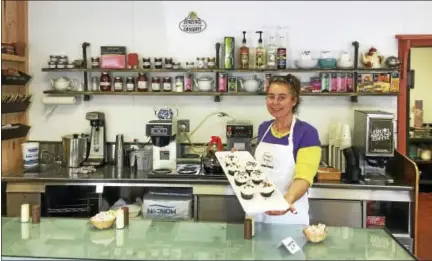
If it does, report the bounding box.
[146,119,177,174]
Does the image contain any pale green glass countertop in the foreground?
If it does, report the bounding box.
[2,218,416,260]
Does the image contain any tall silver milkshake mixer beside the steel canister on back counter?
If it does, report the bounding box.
[83,111,108,167]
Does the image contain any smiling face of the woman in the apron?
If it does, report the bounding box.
[266,83,297,118]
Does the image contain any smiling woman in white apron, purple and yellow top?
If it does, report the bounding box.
[233,74,321,225]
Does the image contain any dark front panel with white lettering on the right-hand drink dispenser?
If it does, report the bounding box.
[368,118,394,154]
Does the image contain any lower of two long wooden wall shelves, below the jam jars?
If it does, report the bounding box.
[43,90,398,97]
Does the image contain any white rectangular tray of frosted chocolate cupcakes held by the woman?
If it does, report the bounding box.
[216,151,289,214]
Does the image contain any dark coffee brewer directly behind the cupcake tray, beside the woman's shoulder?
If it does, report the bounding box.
[226,120,253,153]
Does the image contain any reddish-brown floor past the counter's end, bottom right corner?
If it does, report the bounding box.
[417,193,432,260]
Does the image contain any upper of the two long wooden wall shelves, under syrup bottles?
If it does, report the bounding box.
[42,68,398,73]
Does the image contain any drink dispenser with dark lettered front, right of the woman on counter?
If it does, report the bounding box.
[352,110,395,184]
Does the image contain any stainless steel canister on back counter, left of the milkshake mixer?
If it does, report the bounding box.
[62,134,89,168]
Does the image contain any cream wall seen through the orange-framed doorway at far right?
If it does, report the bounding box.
[410,48,432,126]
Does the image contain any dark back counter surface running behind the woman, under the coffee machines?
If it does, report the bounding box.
[2,165,414,191]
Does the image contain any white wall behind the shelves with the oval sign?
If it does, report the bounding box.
[29,1,432,143]
